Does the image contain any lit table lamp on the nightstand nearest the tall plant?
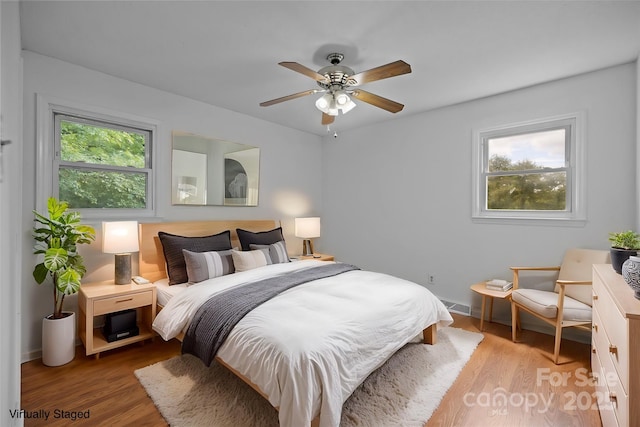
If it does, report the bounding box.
[102,221,139,285]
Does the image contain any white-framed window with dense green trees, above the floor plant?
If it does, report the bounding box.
[38,97,156,218]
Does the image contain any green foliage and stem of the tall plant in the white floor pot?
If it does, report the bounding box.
[33,197,96,319]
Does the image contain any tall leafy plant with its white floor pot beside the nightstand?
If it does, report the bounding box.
[33,197,95,366]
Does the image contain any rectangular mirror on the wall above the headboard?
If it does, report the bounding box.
[171,131,260,206]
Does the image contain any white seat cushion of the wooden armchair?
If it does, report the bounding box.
[511,289,591,322]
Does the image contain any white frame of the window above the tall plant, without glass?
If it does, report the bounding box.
[36,94,159,219]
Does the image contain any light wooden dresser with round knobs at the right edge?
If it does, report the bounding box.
[591,264,640,427]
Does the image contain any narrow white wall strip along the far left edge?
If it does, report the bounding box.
[0,1,23,426]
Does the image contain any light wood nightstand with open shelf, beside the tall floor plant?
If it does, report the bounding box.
[78,280,156,359]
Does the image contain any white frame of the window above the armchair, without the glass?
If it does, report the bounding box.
[472,112,586,226]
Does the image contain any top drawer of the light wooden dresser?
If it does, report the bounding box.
[593,280,629,392]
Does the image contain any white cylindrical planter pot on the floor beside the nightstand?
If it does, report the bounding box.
[42,311,76,366]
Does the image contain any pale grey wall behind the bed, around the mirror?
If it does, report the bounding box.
[21,52,322,359]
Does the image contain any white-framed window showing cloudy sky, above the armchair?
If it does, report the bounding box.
[473,114,584,221]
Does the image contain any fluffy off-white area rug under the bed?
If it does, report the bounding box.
[135,327,482,427]
